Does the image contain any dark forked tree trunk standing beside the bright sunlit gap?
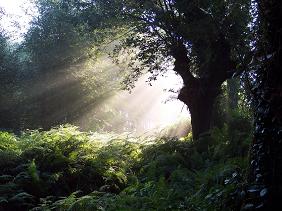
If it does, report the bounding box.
[172,37,234,139]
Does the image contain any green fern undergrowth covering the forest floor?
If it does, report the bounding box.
[0,121,250,211]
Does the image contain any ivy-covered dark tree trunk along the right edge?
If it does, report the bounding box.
[242,0,282,211]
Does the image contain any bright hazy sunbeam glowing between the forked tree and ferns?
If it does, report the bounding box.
[76,57,190,136]
